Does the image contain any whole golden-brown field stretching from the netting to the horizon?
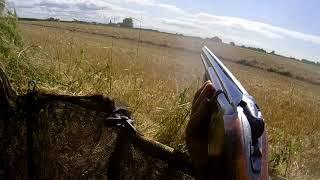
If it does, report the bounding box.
[9,21,320,179]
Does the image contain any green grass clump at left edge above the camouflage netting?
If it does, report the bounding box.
[0,9,59,92]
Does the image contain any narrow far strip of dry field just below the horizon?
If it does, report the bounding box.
[22,21,320,85]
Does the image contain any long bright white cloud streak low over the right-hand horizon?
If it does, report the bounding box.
[161,13,320,45]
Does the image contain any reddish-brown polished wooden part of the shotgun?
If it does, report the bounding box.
[224,109,268,179]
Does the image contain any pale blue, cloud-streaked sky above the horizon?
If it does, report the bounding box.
[9,0,320,62]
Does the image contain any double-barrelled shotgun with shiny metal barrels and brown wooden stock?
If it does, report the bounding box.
[201,46,269,179]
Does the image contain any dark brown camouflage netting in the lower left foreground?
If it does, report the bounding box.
[0,70,193,179]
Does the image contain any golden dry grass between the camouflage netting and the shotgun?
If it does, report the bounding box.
[17,23,200,147]
